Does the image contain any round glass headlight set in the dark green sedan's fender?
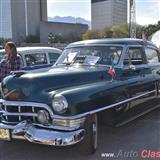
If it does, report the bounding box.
[52,95,68,113]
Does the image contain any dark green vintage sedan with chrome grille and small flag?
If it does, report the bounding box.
[0,39,160,153]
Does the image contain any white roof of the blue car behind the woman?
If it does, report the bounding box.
[0,47,62,53]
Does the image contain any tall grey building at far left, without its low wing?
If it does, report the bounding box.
[0,0,48,42]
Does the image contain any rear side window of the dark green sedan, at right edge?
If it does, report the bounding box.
[145,48,159,64]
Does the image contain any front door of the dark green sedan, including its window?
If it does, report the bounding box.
[119,46,157,120]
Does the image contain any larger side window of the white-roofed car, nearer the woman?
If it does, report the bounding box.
[25,53,47,66]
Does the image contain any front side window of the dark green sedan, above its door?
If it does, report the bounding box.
[123,47,144,65]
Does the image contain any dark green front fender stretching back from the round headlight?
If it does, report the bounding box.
[50,81,129,116]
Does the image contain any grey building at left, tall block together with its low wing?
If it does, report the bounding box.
[0,0,88,44]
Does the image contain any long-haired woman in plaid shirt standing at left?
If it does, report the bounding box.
[0,42,22,81]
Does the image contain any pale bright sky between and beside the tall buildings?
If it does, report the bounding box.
[48,0,160,25]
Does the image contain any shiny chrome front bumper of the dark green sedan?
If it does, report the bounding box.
[0,121,85,146]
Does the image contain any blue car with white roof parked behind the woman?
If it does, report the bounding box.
[0,47,62,72]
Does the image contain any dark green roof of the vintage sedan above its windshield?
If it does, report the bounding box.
[67,38,157,48]
